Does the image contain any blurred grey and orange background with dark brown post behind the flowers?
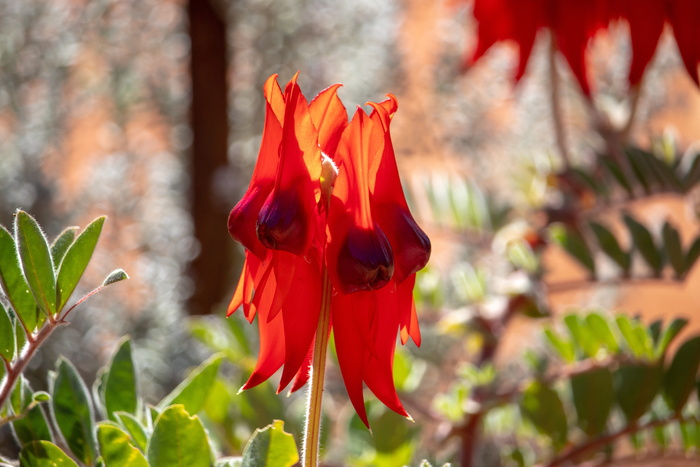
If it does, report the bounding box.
[0,0,700,465]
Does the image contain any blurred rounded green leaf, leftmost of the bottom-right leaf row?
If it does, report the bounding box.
[520,381,568,450]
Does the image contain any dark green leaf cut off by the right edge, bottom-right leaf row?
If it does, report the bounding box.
[663,336,700,412]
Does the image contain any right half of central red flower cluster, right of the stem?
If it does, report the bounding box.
[328,95,430,424]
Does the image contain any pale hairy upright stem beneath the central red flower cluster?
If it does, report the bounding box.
[302,267,332,467]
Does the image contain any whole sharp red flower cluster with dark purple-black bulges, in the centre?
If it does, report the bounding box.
[228,72,430,425]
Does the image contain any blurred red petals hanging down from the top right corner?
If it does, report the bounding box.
[468,0,700,95]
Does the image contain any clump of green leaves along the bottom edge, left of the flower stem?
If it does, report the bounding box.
[1,332,299,467]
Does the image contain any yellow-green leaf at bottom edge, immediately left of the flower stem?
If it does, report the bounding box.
[241,420,299,467]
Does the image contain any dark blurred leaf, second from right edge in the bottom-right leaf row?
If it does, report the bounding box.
[615,362,664,424]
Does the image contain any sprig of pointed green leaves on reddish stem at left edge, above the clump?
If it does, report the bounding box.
[0,211,127,426]
